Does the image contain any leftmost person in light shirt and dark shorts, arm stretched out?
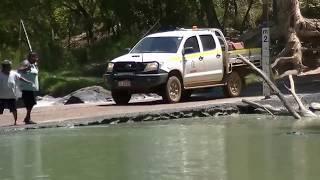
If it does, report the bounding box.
[0,60,33,125]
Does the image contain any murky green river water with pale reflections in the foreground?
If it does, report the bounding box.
[0,116,320,180]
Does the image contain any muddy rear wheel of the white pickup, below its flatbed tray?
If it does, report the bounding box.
[223,71,242,97]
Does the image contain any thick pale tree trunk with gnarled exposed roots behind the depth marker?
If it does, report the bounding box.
[272,0,320,77]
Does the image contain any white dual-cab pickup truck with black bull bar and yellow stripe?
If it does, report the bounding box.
[104,29,261,104]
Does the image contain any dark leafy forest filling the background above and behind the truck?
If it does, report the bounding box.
[0,0,320,95]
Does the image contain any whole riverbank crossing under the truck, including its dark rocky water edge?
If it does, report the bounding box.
[0,75,320,133]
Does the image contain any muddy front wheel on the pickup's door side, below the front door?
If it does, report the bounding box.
[162,76,182,103]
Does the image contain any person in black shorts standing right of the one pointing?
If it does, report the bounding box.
[18,52,39,124]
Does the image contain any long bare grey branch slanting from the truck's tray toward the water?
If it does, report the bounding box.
[238,54,301,119]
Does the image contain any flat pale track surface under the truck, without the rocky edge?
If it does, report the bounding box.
[0,93,262,127]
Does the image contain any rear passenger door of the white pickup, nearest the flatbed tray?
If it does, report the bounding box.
[200,34,224,82]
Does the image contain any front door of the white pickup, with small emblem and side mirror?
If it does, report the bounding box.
[183,36,205,88]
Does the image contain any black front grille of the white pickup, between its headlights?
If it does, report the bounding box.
[113,62,145,73]
